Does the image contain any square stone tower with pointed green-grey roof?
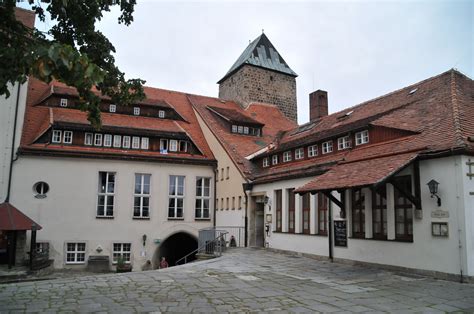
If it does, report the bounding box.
[217,34,298,122]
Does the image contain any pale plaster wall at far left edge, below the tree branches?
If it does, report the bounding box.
[0,83,28,203]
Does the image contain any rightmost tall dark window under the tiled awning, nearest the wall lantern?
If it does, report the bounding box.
[395,176,413,241]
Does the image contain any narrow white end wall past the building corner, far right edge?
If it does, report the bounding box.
[460,156,474,276]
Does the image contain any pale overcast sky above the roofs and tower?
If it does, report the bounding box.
[30,0,474,123]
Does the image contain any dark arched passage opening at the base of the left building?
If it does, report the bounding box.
[155,232,198,266]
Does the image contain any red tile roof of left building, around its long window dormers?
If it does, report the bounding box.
[21,78,215,162]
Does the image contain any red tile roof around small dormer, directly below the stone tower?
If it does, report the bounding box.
[189,95,295,179]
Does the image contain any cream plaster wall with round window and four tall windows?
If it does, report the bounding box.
[12,156,214,269]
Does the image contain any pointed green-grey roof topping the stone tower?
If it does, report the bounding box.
[217,33,298,84]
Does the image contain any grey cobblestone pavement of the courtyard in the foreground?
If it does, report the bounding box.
[0,249,474,313]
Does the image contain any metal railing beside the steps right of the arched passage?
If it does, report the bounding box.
[175,228,228,265]
